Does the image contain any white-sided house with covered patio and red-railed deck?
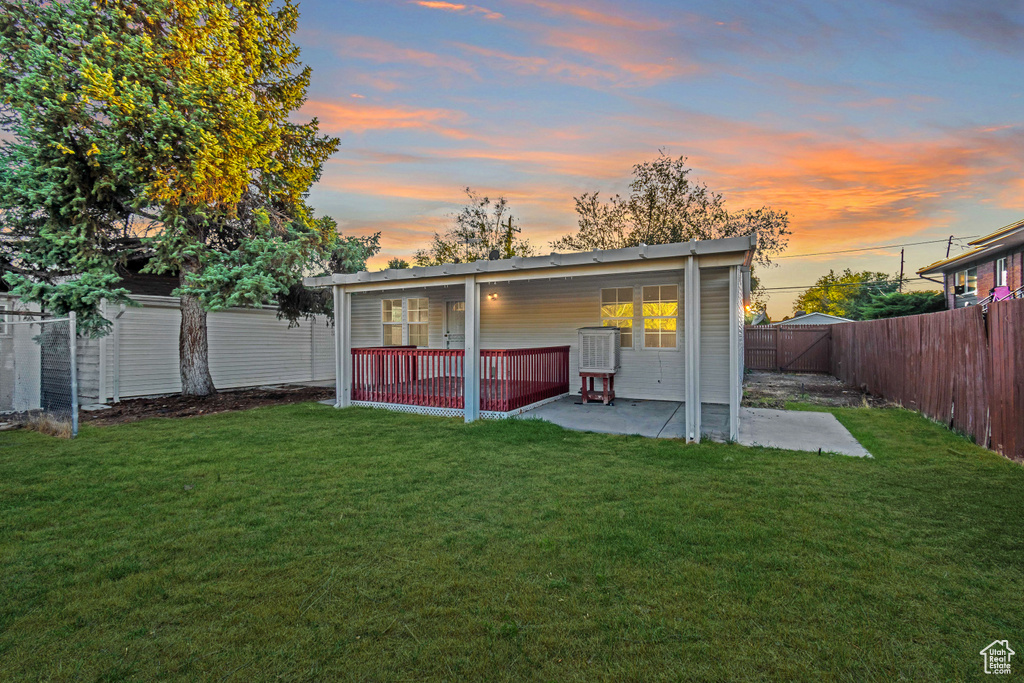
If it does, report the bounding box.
[305,237,755,441]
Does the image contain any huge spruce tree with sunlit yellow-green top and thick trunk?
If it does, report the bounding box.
[0,0,344,395]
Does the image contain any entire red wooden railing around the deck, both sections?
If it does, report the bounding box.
[352,346,569,413]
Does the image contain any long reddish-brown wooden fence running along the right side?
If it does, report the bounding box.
[831,299,1024,460]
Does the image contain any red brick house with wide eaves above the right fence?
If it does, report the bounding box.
[918,220,1024,308]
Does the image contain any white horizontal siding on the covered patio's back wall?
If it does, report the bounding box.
[351,270,692,401]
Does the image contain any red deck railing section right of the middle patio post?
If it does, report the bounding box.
[480,346,569,413]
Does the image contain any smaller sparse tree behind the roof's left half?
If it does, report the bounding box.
[413,187,534,265]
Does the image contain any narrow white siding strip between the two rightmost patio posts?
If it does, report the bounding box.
[700,268,734,404]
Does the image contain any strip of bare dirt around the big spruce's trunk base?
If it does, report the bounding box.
[79,386,334,425]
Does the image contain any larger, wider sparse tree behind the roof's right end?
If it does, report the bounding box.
[551,153,791,304]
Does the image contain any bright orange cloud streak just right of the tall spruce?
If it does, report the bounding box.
[300,100,471,139]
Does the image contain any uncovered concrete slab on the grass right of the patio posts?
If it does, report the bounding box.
[739,408,871,458]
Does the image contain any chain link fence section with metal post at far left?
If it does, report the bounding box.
[0,312,78,437]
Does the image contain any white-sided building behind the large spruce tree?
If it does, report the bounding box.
[0,274,335,412]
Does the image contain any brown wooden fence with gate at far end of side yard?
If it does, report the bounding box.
[743,325,834,373]
